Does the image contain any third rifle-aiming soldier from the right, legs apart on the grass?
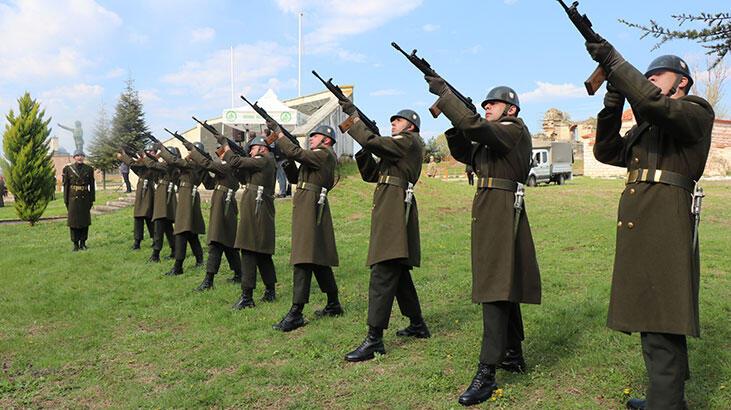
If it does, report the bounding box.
[341,102,431,362]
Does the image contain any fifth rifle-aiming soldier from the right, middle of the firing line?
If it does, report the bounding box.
[223,137,277,309]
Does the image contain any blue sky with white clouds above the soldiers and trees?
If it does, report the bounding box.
[0,0,731,149]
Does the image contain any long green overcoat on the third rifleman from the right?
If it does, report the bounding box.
[348,121,424,267]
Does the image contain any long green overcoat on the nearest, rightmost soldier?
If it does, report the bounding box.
[594,62,714,337]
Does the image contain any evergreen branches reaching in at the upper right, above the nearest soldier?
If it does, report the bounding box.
[619,13,731,67]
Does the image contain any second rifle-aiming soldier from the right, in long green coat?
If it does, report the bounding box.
[425,76,541,406]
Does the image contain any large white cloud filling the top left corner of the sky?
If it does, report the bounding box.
[0,0,122,81]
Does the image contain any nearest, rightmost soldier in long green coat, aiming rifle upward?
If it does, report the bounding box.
[586,41,715,409]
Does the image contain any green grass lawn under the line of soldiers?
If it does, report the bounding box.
[0,176,731,409]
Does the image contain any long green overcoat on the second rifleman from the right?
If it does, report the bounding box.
[437,93,541,304]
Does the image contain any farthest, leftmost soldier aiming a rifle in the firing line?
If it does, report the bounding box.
[117,144,158,250]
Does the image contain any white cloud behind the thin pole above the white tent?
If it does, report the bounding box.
[162,41,294,101]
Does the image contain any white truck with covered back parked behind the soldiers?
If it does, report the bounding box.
[526,142,574,186]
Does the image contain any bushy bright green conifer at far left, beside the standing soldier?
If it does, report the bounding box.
[0,92,56,226]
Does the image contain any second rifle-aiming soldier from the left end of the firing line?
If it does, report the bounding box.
[143,147,180,262]
